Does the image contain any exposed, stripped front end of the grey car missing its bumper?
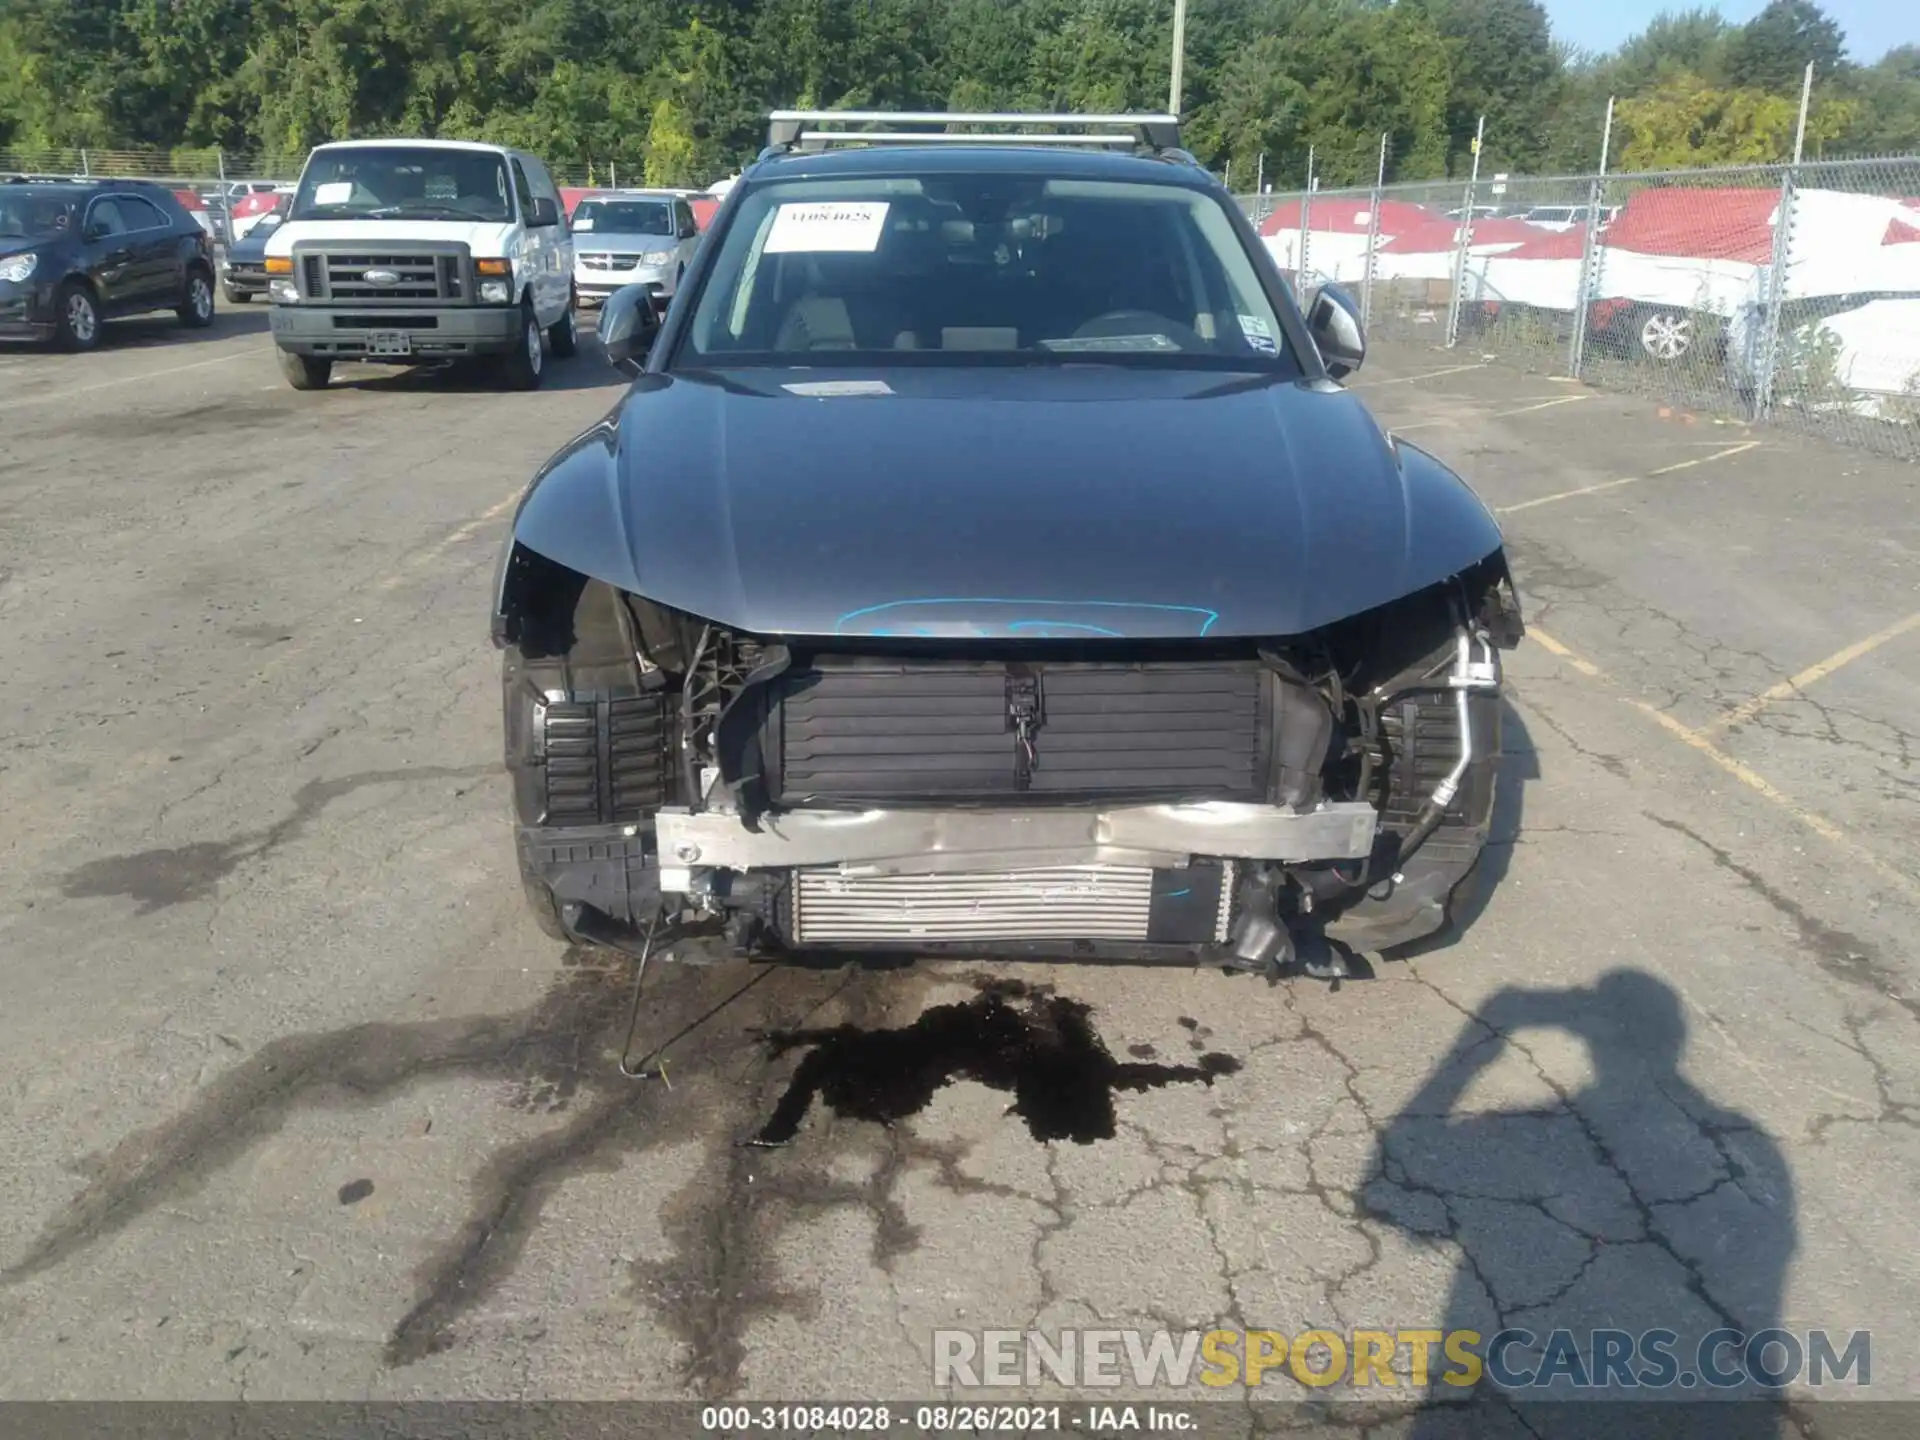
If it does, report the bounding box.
[493,526,1523,970]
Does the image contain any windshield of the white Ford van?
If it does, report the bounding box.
[288,146,513,221]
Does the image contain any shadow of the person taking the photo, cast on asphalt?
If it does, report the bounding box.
[1365,970,1805,1440]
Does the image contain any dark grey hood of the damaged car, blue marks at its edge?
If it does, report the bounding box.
[515,365,1500,637]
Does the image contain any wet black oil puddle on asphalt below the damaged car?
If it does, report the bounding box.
[755,979,1240,1144]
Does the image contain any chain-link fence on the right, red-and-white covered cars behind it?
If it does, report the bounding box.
[1240,156,1920,461]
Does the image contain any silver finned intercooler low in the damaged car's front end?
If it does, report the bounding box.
[789,864,1233,945]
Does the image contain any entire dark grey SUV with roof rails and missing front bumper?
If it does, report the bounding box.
[493,111,1523,972]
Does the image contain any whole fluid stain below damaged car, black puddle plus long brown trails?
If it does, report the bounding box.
[0,960,1238,1398]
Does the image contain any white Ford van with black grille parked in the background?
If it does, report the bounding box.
[267,140,576,390]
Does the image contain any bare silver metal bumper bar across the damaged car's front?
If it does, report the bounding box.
[655,801,1379,889]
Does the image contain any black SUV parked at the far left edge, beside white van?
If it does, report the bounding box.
[0,177,213,349]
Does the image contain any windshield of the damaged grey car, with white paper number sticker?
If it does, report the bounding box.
[676,175,1290,369]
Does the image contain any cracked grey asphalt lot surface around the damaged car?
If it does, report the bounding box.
[0,309,1920,1434]
